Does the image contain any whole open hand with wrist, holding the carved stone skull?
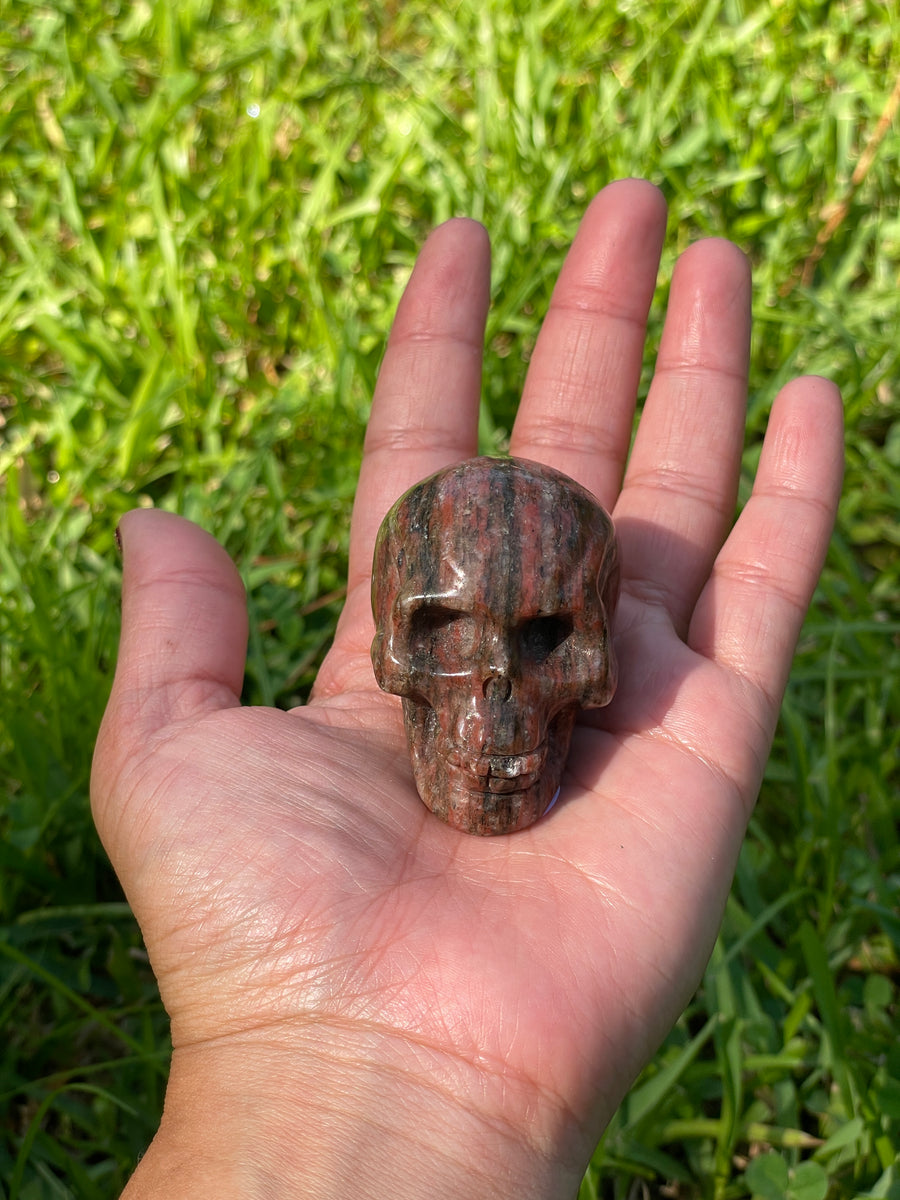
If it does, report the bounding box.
[92,181,842,1200]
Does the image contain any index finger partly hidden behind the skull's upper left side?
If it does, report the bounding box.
[349,220,491,590]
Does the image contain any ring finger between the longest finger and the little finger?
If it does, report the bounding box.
[616,239,750,636]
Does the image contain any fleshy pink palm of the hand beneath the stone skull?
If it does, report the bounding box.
[111,588,724,1087]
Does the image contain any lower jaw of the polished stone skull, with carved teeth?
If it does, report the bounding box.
[403,698,577,838]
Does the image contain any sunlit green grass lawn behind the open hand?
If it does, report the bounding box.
[0,0,900,1200]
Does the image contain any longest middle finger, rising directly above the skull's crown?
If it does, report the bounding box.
[511,179,666,508]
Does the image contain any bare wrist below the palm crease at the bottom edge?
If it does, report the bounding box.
[124,1026,581,1200]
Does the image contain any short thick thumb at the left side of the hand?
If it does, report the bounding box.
[102,510,247,757]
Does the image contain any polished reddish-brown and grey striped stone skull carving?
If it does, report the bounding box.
[372,457,618,834]
